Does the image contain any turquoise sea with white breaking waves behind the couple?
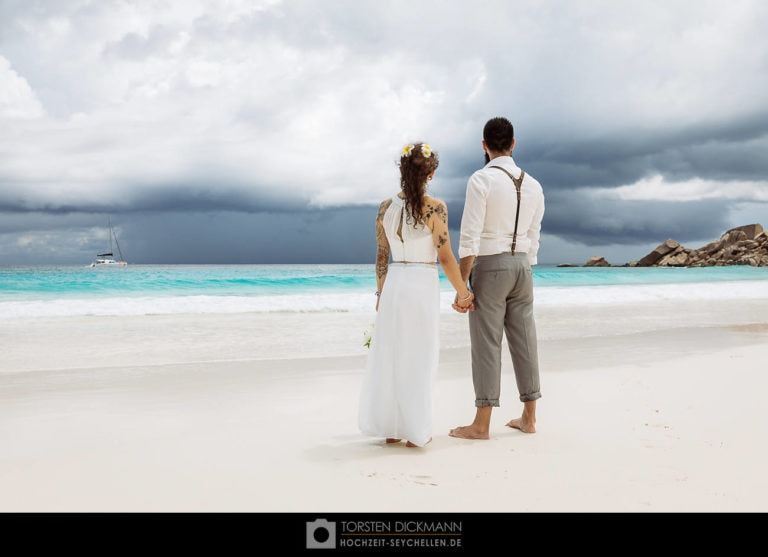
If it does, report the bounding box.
[0,264,768,321]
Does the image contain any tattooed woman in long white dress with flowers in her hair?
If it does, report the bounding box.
[358,143,474,447]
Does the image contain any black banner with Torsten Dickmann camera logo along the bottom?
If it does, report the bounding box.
[0,513,766,556]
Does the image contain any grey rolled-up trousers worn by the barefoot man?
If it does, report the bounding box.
[469,253,541,408]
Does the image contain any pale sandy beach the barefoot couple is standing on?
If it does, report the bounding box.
[0,300,768,513]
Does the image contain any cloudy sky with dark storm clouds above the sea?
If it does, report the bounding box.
[0,0,768,265]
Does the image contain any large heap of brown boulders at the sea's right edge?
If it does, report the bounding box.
[628,224,768,267]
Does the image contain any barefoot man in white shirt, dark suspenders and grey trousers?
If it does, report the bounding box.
[450,118,544,439]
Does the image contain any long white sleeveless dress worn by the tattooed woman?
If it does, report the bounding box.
[359,196,440,446]
